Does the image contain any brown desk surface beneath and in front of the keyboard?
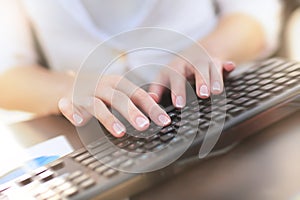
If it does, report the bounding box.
[3,112,300,200]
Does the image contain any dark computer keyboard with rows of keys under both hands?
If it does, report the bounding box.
[0,58,300,199]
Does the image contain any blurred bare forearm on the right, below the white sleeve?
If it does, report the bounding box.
[200,13,265,63]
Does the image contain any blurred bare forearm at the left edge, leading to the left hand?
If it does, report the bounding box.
[0,66,73,115]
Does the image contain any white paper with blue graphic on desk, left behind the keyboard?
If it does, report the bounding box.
[0,136,74,184]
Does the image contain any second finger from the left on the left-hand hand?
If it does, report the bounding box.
[88,98,126,137]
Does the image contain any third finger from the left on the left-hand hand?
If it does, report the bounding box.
[97,88,150,131]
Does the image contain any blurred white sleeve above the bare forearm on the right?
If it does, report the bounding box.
[217,0,283,58]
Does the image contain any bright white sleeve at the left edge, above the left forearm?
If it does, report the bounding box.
[0,0,37,72]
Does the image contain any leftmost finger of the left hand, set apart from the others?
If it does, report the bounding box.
[58,98,92,126]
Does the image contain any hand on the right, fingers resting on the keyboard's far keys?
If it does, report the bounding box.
[149,54,235,108]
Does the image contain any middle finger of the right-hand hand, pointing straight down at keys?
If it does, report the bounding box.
[194,60,210,99]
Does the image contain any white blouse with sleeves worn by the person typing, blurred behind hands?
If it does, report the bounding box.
[0,0,281,78]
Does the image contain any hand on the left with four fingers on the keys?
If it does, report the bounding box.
[58,75,171,137]
